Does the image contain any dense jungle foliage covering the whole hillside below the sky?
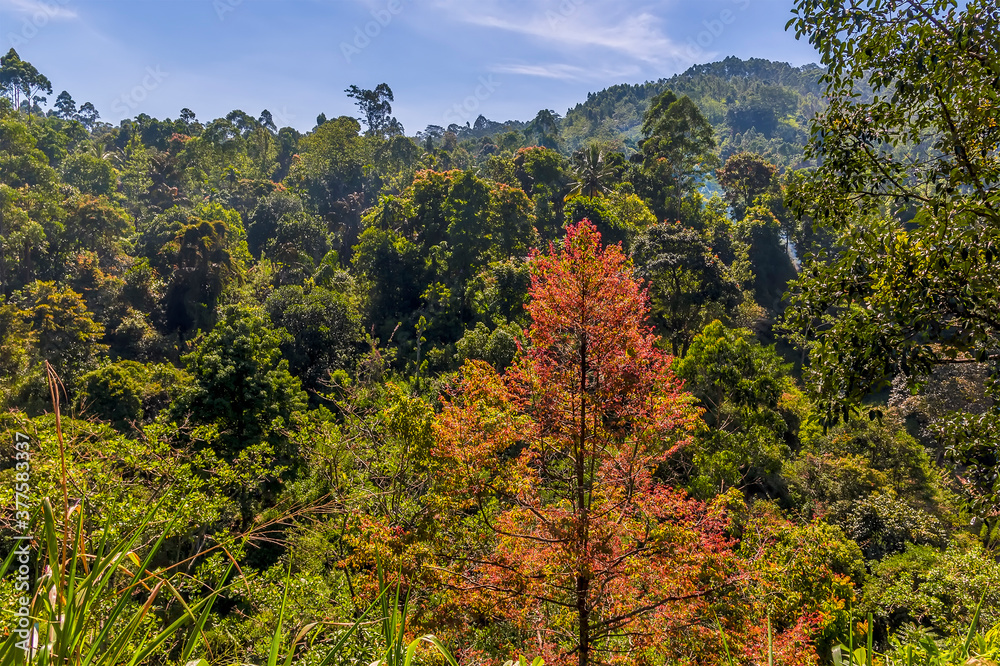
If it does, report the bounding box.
[0,0,1000,666]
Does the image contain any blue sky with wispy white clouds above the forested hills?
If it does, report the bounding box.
[0,0,817,134]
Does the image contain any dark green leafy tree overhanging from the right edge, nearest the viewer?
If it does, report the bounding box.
[786,0,1000,536]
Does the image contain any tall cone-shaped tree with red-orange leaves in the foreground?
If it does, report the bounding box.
[435,220,734,666]
